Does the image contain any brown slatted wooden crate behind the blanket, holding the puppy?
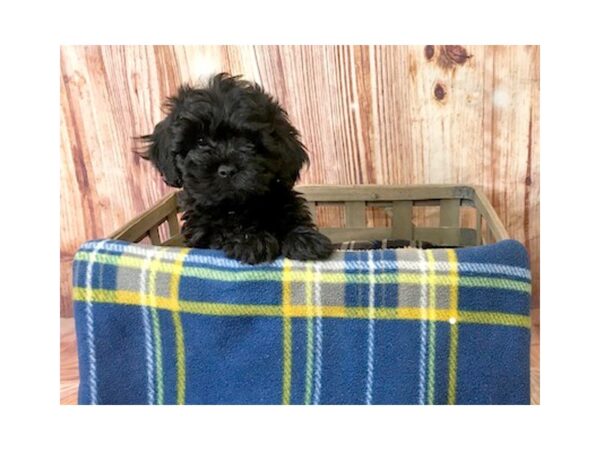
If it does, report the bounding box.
[110,184,509,247]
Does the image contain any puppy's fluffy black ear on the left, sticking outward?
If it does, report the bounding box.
[140,86,192,187]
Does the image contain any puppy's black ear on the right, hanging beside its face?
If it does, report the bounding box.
[272,110,309,188]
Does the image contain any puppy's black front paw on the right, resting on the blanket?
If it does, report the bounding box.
[281,227,333,261]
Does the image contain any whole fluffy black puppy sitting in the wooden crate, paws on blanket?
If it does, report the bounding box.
[142,73,333,264]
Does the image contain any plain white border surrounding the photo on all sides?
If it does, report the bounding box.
[0,0,600,450]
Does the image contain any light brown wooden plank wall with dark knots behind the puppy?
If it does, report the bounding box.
[60,45,539,316]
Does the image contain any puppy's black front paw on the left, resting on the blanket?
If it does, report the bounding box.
[223,232,279,264]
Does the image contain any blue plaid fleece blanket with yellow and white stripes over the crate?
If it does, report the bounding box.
[73,240,530,404]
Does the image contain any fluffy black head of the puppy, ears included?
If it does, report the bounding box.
[144,74,308,205]
